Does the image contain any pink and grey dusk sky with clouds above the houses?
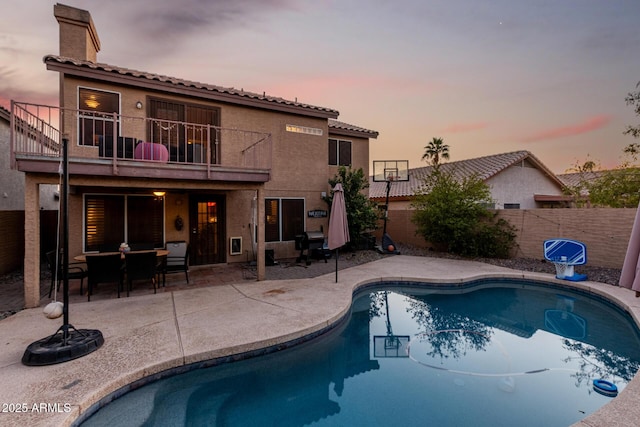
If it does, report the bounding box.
[0,0,640,173]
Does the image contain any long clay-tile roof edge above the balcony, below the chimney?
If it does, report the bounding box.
[43,55,339,118]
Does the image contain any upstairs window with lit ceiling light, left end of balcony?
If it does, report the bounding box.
[78,87,120,145]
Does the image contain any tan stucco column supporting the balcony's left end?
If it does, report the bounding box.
[24,174,40,308]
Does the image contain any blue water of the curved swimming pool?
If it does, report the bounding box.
[83,282,640,426]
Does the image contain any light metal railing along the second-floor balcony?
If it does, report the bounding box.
[11,101,272,176]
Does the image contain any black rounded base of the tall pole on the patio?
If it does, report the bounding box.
[22,325,104,366]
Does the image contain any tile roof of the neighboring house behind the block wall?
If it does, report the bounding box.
[369,151,563,199]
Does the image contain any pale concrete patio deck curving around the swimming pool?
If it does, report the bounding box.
[0,256,640,426]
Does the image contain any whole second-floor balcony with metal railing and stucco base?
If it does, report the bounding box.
[11,101,272,183]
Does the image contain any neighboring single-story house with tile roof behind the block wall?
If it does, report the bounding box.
[369,151,570,210]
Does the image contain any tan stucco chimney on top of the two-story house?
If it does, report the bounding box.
[53,3,100,62]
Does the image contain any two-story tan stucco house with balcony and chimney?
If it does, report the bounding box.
[12,4,378,306]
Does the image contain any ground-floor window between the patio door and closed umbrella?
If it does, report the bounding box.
[264,199,304,242]
